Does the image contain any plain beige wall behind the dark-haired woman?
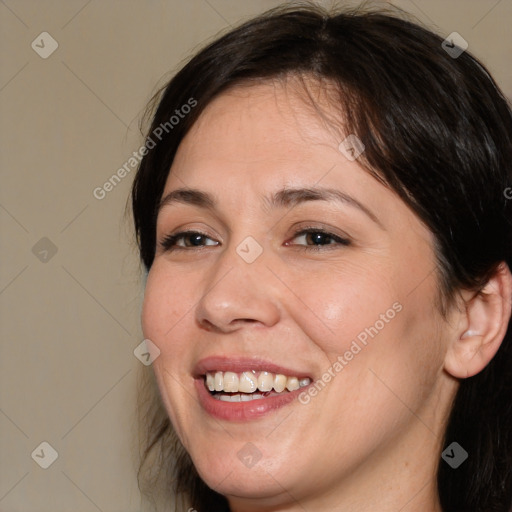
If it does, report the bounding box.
[0,0,512,512]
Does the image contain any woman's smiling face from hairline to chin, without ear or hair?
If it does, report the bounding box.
[143,80,456,510]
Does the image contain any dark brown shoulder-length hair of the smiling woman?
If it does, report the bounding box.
[132,5,512,512]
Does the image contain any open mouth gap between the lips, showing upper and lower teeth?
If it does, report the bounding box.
[204,370,311,402]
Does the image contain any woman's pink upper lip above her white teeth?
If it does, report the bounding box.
[193,356,311,379]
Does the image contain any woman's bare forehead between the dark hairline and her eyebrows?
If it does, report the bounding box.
[164,82,364,205]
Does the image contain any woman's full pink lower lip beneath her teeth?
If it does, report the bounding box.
[195,378,307,422]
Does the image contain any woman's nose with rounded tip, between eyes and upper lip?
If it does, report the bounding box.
[196,243,281,333]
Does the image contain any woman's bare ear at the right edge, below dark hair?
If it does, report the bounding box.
[444,262,512,379]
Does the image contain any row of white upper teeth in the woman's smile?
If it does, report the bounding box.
[206,371,311,393]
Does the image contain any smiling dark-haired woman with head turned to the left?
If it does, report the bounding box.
[132,6,512,512]
